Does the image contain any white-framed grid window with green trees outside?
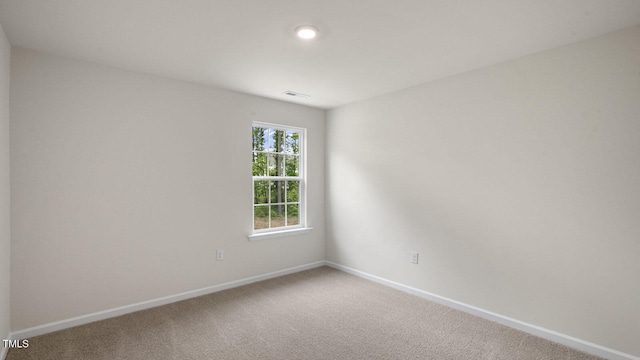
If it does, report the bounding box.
[252,123,305,234]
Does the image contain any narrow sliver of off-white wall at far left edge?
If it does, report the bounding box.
[0,26,11,346]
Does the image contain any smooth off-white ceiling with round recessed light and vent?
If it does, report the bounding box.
[0,0,640,108]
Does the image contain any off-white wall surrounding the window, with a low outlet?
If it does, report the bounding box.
[11,48,325,331]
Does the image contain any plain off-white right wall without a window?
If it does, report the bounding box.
[326,27,640,356]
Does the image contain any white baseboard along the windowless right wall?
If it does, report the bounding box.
[326,261,640,360]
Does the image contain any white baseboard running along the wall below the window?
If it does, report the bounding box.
[10,261,326,342]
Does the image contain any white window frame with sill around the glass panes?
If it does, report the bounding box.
[249,121,311,241]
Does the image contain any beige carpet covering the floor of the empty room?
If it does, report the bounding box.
[7,267,598,360]
